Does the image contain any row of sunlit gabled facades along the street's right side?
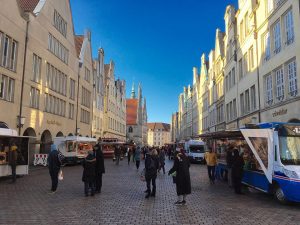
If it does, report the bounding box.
[172,0,300,141]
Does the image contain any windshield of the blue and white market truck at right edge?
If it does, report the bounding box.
[279,137,300,165]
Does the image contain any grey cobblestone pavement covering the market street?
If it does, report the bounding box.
[0,160,300,225]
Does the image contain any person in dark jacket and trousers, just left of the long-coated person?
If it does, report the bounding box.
[145,149,159,198]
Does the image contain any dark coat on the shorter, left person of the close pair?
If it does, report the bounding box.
[82,154,96,182]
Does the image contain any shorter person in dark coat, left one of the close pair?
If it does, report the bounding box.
[82,151,96,196]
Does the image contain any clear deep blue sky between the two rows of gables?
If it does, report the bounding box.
[71,0,237,123]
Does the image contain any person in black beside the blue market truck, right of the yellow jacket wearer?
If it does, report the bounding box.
[232,148,244,194]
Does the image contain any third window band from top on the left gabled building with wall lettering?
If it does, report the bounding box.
[46,63,67,96]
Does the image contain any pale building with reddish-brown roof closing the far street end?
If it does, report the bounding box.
[147,123,171,147]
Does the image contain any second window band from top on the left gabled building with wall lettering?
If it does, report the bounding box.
[48,33,69,64]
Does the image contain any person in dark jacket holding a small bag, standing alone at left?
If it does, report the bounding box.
[48,144,61,193]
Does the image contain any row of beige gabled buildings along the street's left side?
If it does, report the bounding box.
[0,0,126,156]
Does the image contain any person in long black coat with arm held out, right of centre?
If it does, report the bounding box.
[168,149,191,205]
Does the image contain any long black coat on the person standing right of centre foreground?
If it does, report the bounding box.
[169,153,191,195]
